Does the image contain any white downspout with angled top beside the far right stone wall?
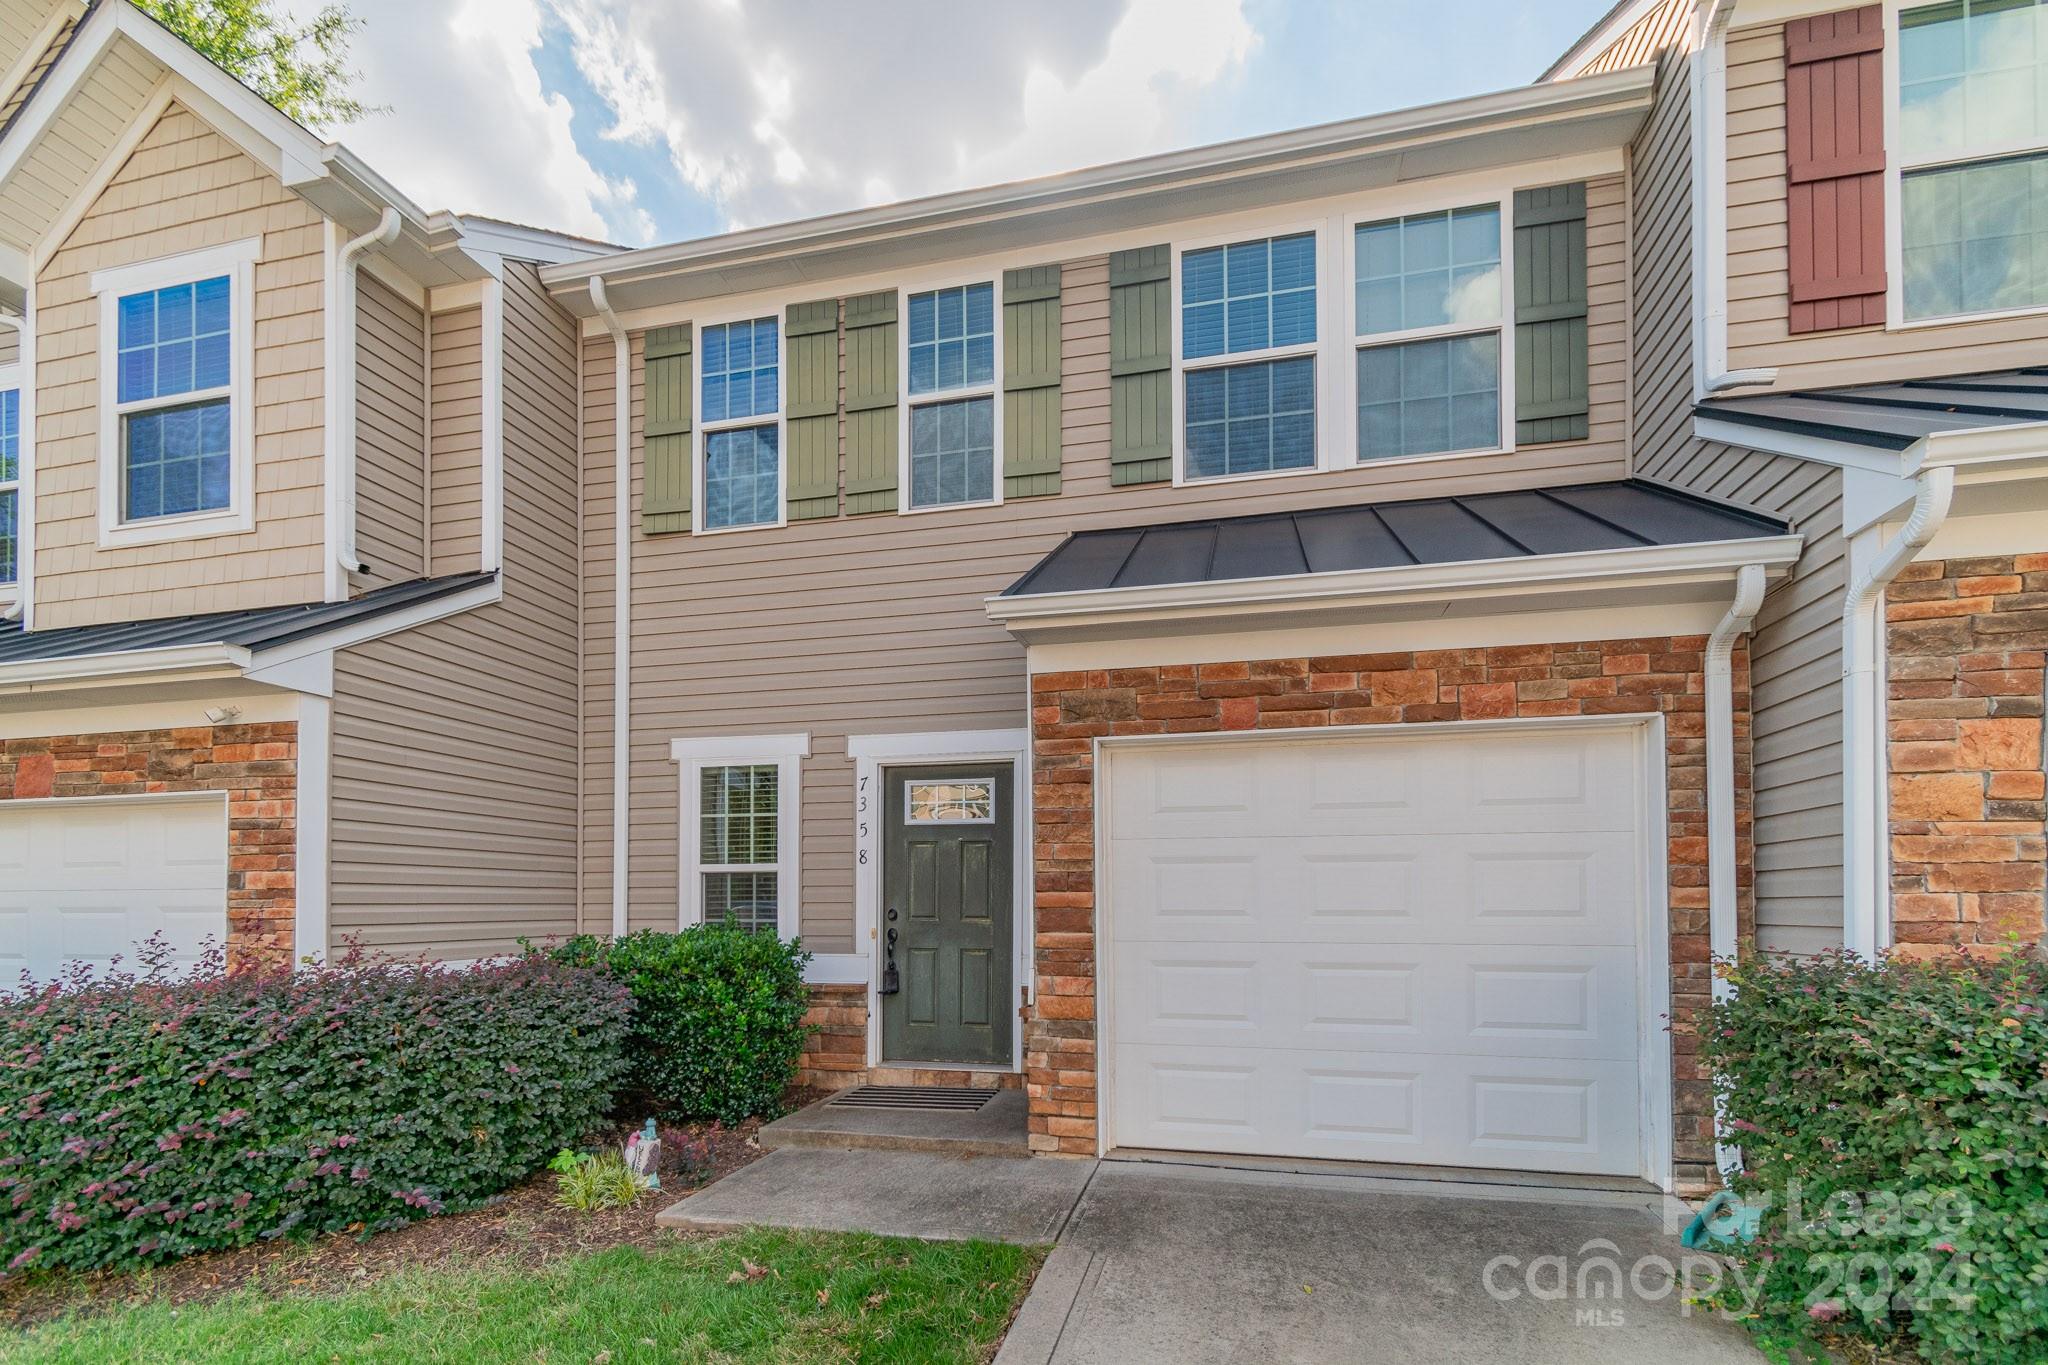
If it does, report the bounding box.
[1841,467,1956,960]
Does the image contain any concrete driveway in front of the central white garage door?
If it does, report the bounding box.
[997,1160,1763,1365]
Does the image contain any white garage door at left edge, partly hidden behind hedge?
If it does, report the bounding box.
[0,796,227,988]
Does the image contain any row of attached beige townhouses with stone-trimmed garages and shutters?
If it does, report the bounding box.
[0,0,2048,1187]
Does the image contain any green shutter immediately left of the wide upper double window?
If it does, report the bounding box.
[1110,246,1174,487]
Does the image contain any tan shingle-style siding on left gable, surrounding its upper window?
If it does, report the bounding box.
[35,104,326,628]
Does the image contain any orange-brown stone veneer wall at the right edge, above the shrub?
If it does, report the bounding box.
[1884,555,2048,952]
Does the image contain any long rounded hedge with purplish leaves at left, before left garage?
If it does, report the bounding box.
[0,956,631,1275]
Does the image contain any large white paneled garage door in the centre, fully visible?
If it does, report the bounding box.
[1104,726,1649,1175]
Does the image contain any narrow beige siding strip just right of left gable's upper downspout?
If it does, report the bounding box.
[356,270,426,587]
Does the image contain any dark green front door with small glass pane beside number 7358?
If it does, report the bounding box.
[881,763,1016,1066]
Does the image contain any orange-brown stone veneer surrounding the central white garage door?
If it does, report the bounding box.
[1026,636,1753,1185]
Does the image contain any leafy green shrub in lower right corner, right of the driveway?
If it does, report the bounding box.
[1700,952,2048,1365]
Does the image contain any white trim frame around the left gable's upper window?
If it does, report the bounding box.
[90,237,262,548]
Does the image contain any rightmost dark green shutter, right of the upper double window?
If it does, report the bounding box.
[1516,184,1589,446]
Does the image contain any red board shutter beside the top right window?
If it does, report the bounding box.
[1786,4,1884,332]
